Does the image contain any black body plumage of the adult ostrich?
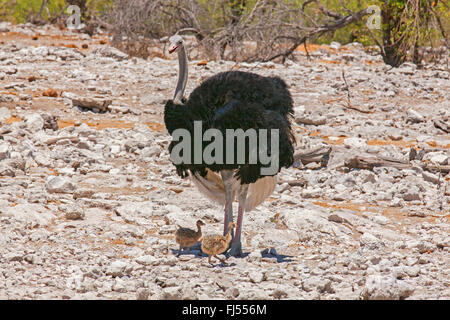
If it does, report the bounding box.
[164,71,295,184]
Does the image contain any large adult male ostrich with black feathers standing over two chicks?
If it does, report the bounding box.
[164,35,295,256]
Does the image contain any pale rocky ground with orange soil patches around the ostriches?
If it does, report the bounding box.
[0,23,450,299]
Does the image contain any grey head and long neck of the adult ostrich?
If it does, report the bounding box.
[169,34,188,103]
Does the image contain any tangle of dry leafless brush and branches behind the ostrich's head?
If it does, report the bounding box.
[108,0,369,62]
